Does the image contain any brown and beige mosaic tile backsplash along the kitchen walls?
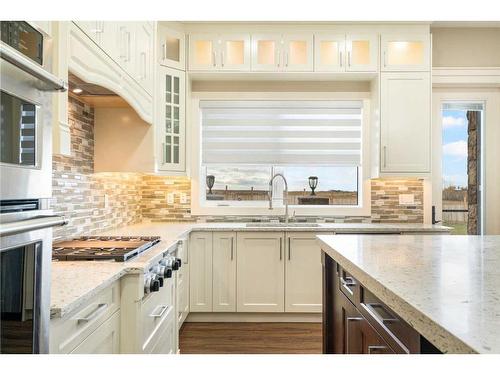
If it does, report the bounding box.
[52,97,423,239]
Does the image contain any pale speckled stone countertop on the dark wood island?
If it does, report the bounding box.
[318,235,500,353]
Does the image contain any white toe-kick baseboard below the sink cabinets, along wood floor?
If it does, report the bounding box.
[186,313,322,323]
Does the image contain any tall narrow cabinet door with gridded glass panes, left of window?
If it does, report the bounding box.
[155,66,186,171]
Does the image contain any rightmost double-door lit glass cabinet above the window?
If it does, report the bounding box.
[314,34,378,72]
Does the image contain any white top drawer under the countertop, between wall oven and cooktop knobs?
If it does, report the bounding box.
[50,281,120,353]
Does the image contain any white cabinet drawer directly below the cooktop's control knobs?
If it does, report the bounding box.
[141,278,175,351]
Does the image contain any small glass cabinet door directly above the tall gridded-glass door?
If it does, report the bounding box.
[158,25,186,70]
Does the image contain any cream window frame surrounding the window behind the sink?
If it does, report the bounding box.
[188,92,371,216]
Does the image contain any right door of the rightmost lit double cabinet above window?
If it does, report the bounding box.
[346,34,378,72]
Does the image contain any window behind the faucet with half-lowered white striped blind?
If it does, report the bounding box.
[193,100,369,216]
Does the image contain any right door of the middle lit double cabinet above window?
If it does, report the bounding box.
[283,35,313,72]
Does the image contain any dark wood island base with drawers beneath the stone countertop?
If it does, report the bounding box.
[322,252,441,354]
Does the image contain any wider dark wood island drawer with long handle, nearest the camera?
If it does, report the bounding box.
[359,285,420,353]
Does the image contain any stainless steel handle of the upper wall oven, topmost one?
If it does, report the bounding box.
[0,42,68,92]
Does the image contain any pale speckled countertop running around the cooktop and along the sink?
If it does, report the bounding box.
[50,222,449,318]
